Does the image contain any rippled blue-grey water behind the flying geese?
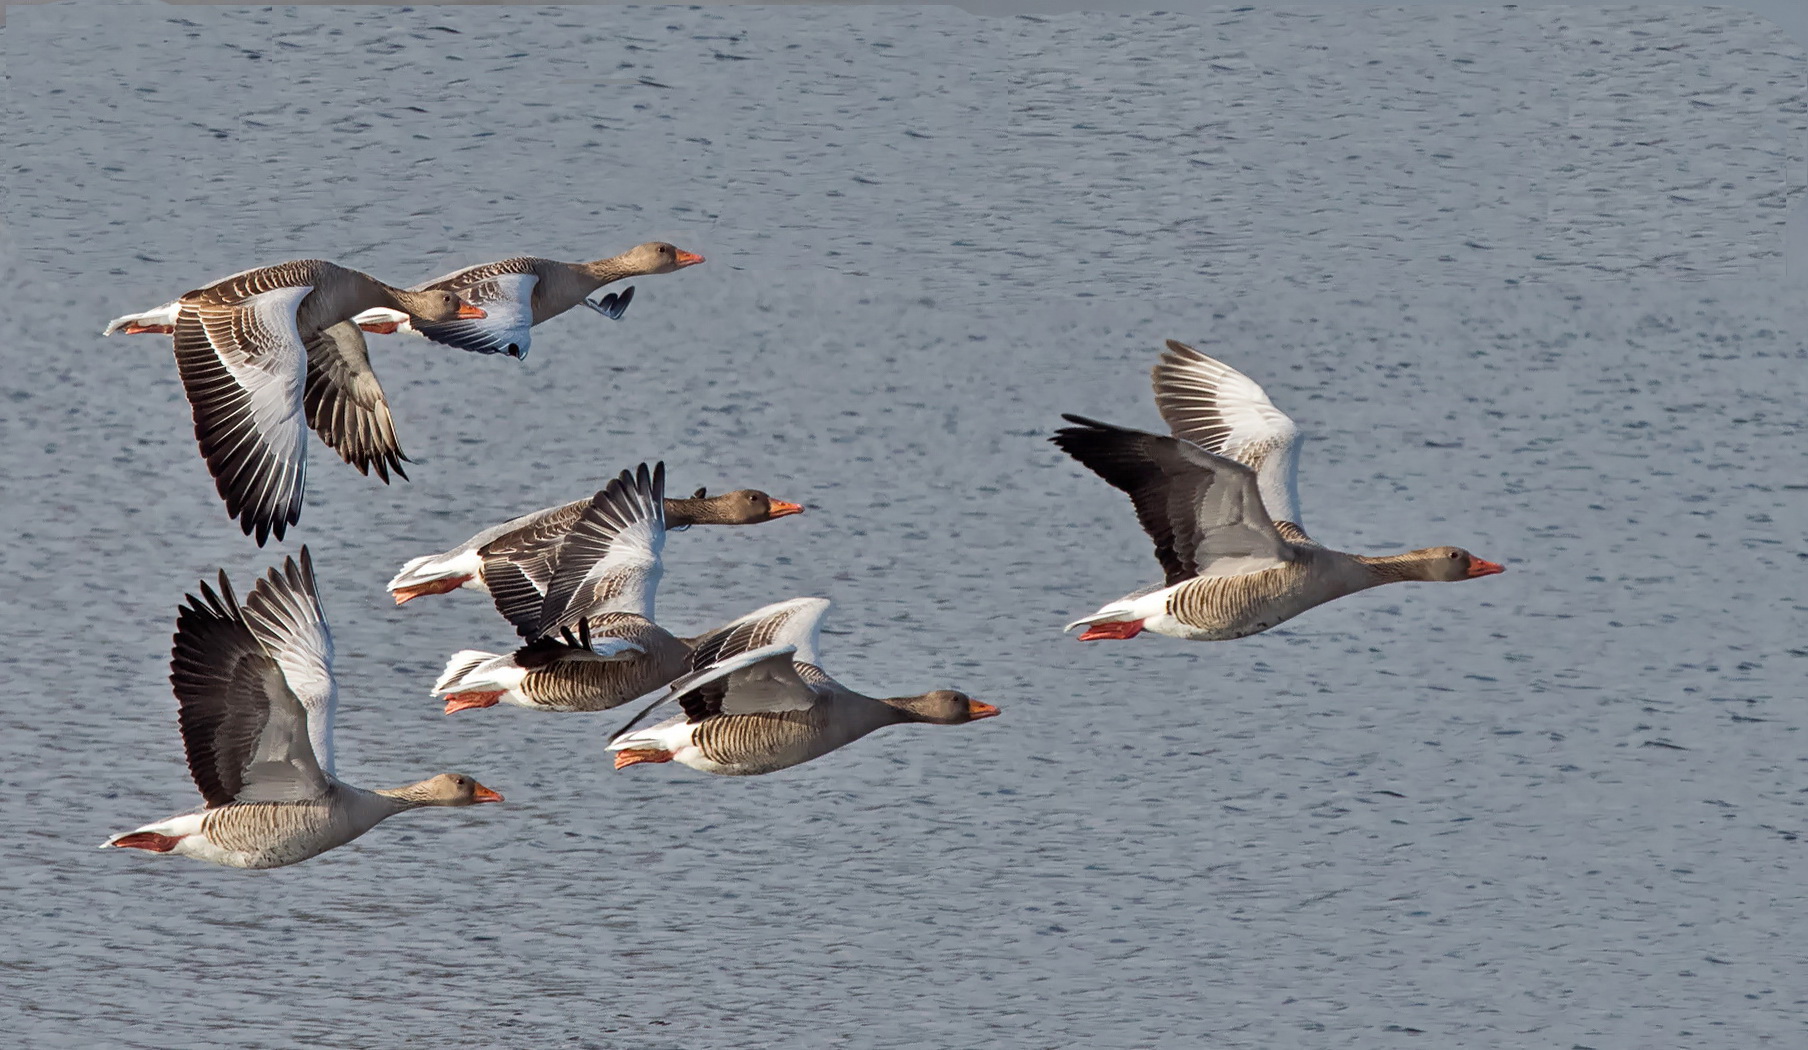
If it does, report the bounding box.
[0,5,1808,1048]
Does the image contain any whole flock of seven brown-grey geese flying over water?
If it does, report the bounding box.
[91,242,1502,867]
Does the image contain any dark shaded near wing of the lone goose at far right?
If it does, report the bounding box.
[1050,416,1295,586]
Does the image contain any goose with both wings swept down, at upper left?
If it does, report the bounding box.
[103,258,485,546]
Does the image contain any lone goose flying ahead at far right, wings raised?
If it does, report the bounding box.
[1050,340,1504,642]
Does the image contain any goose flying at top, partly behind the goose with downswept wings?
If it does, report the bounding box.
[356,240,703,360]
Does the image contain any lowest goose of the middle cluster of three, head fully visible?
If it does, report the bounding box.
[607,598,998,777]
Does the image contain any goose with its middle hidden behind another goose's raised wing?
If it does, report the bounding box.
[385,488,803,605]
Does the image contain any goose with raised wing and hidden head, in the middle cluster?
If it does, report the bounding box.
[432,463,691,714]
